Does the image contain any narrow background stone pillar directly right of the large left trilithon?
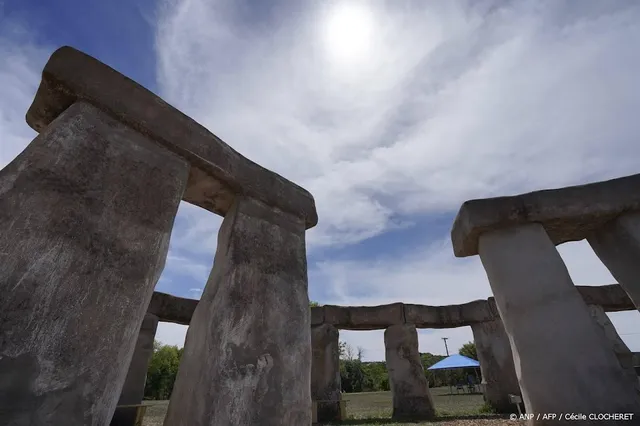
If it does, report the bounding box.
[311,324,342,422]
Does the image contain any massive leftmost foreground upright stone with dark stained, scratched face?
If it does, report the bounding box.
[0,102,189,426]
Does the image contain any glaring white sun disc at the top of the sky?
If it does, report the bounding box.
[325,2,374,62]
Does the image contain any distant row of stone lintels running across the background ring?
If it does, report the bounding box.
[148,284,636,330]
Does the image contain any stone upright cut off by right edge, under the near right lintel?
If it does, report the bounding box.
[587,212,640,309]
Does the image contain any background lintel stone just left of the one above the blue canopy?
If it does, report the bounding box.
[323,303,404,330]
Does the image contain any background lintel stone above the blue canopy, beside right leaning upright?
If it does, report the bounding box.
[404,300,495,328]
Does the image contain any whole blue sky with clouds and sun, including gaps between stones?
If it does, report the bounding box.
[0,0,640,360]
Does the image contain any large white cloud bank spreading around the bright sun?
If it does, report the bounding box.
[157,0,640,246]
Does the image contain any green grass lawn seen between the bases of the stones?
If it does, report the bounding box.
[143,387,524,426]
